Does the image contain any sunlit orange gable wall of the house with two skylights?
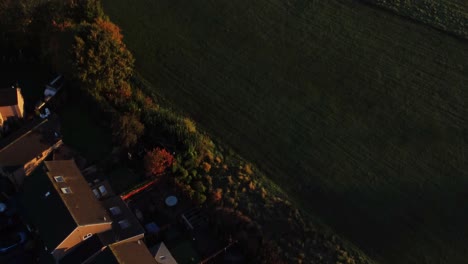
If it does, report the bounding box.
[52,222,112,261]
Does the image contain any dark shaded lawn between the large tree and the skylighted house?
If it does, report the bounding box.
[59,103,112,162]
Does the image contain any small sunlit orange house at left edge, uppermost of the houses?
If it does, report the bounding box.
[0,88,24,127]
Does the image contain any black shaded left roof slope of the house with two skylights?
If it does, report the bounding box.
[20,169,77,251]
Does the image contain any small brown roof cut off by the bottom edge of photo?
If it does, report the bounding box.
[109,240,157,264]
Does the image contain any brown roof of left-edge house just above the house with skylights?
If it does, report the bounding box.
[0,117,60,167]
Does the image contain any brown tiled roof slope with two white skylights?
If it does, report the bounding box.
[44,160,112,225]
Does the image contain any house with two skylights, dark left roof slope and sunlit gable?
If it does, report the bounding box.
[22,160,112,261]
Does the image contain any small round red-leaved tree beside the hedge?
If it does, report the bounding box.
[112,114,145,148]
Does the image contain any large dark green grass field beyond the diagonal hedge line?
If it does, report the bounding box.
[103,0,468,263]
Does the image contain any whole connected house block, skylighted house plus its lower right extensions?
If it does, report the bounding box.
[20,160,164,264]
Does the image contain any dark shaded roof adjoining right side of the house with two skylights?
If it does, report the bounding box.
[102,196,145,244]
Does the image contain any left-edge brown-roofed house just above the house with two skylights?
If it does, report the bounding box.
[0,116,62,188]
